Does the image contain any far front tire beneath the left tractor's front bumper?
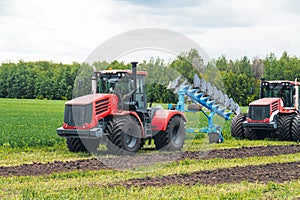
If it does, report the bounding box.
[66,138,99,153]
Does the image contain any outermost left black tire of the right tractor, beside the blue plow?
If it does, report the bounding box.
[230,113,246,139]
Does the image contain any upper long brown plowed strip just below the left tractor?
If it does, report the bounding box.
[0,145,300,177]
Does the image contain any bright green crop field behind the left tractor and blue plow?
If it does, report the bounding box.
[0,99,241,147]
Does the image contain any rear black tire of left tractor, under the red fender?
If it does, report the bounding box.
[153,116,185,151]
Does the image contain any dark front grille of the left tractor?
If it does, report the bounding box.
[64,104,92,126]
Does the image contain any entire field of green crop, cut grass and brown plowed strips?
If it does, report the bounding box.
[0,99,300,199]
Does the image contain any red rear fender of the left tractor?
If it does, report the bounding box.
[151,109,187,131]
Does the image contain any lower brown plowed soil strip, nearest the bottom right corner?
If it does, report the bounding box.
[109,162,300,188]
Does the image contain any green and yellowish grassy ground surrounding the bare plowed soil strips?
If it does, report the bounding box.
[0,99,300,199]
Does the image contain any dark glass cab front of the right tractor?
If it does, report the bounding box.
[262,82,295,107]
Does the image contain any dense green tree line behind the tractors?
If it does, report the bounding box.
[0,49,300,106]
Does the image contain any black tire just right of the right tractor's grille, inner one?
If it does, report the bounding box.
[274,114,295,141]
